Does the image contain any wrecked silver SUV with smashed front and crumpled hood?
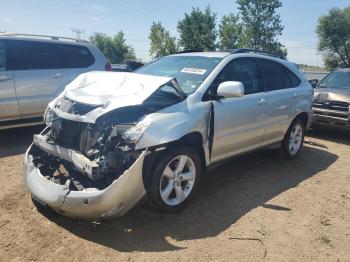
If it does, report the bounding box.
[24,49,313,219]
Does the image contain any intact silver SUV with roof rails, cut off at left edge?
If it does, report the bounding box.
[0,34,110,129]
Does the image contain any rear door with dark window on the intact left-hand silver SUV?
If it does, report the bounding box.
[8,40,68,118]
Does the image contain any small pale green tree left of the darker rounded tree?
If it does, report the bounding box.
[148,22,177,57]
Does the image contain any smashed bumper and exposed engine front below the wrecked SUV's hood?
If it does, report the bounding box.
[25,116,147,219]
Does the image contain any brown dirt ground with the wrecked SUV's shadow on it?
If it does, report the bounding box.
[0,128,350,261]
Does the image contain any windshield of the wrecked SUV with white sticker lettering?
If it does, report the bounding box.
[136,56,222,95]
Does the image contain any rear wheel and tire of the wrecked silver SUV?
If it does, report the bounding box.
[282,119,306,159]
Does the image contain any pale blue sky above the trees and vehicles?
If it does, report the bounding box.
[0,0,350,66]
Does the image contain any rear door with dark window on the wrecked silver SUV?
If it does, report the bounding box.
[257,59,300,145]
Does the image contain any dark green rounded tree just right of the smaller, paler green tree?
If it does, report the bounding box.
[177,6,217,51]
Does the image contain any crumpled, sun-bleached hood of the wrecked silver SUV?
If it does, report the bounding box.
[49,71,173,123]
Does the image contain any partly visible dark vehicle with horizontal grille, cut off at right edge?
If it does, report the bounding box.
[312,68,350,129]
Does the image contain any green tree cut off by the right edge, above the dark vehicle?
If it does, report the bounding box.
[316,7,350,69]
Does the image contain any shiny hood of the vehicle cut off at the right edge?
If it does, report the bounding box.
[314,88,350,104]
